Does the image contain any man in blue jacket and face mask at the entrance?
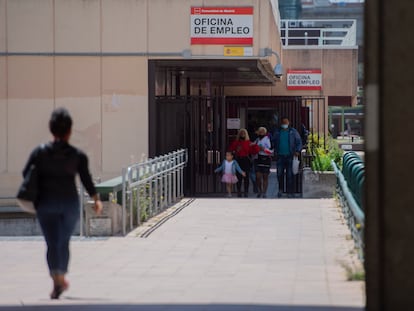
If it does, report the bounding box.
[273,117,302,198]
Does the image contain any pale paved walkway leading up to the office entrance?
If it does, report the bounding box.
[0,199,364,311]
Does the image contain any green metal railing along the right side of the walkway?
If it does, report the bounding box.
[332,152,365,259]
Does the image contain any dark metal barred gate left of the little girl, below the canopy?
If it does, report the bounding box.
[155,96,226,196]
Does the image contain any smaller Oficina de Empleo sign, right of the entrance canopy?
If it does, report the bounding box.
[287,69,322,91]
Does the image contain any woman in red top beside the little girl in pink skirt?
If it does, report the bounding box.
[229,129,259,198]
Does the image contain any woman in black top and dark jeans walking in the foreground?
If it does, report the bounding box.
[23,108,102,299]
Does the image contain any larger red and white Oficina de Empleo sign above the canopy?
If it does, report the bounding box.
[191,7,253,45]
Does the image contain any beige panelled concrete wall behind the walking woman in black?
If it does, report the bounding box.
[0,0,280,196]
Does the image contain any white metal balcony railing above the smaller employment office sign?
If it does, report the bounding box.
[280,19,357,48]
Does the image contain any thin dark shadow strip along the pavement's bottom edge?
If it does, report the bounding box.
[0,304,364,311]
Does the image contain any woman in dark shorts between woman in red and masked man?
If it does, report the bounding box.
[255,127,272,198]
